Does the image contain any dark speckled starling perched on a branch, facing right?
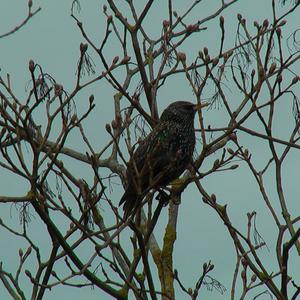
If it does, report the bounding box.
[119,101,204,219]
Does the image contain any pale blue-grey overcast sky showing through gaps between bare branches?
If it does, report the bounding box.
[0,0,300,300]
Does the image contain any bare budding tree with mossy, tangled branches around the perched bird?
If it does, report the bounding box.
[0,0,300,300]
